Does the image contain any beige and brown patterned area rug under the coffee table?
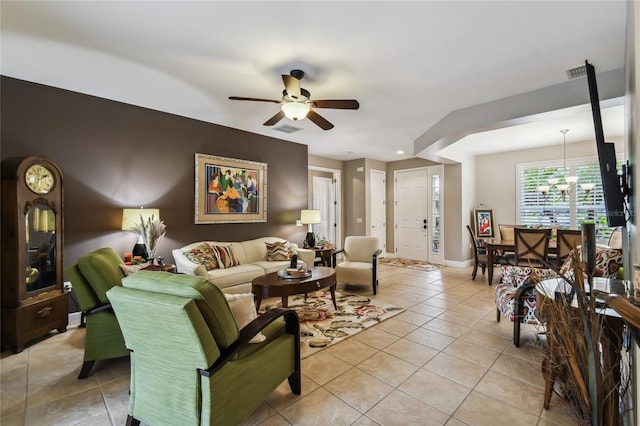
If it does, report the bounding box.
[260,289,404,358]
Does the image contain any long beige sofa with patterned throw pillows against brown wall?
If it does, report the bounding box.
[172,237,315,293]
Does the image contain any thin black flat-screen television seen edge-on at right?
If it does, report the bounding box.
[585,61,626,227]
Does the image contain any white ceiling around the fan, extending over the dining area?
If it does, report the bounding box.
[0,1,626,161]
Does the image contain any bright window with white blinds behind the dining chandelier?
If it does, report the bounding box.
[516,155,622,241]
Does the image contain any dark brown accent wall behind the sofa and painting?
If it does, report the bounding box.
[0,76,308,265]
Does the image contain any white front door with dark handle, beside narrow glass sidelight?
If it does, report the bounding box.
[395,168,429,261]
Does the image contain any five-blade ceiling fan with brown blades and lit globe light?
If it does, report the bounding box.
[229,70,360,130]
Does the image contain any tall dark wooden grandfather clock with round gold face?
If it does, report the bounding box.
[0,156,69,352]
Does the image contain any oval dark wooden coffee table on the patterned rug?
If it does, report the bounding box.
[251,266,338,310]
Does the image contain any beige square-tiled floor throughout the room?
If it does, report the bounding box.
[0,265,576,426]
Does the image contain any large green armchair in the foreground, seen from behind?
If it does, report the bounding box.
[107,271,301,425]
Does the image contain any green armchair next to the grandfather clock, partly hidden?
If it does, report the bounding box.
[65,247,129,379]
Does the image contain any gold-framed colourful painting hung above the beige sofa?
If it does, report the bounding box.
[195,153,267,224]
